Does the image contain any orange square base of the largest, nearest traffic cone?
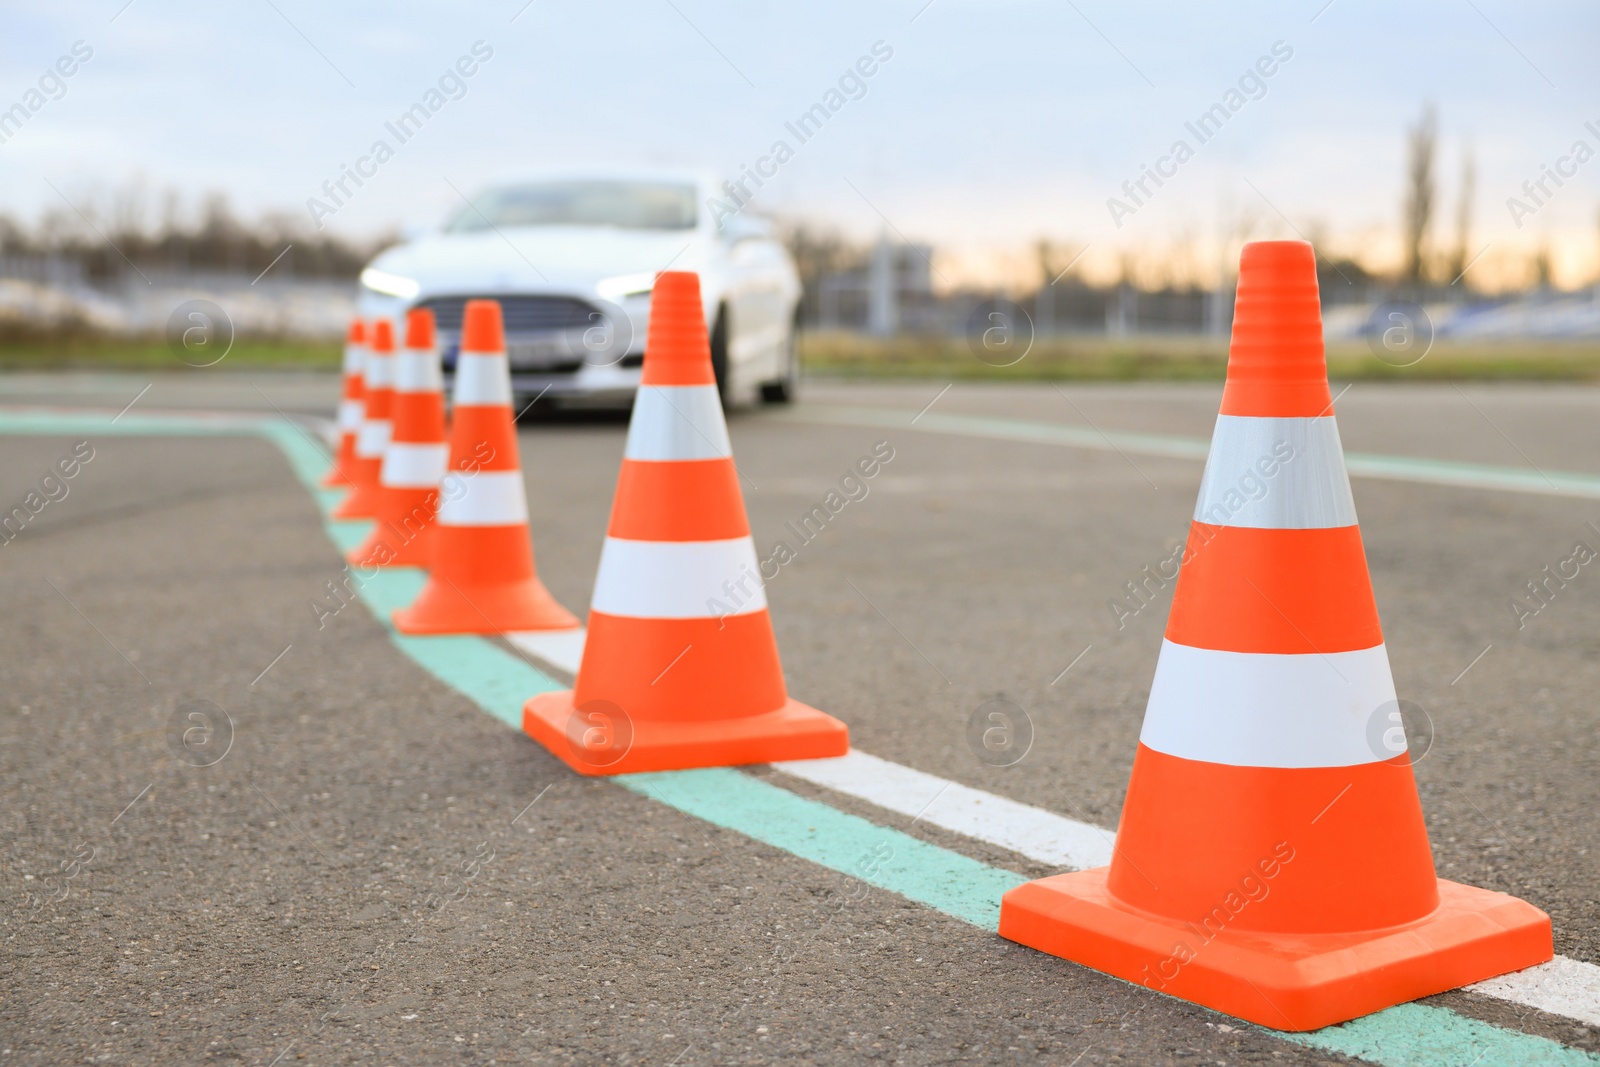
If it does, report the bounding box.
[1000,867,1554,1030]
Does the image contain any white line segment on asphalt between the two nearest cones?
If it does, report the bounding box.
[773,749,1115,870]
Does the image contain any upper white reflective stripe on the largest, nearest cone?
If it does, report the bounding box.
[1195,414,1355,530]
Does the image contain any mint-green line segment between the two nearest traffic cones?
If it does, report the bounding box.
[616,768,1027,931]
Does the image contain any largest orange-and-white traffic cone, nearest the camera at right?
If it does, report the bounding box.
[1000,242,1552,1030]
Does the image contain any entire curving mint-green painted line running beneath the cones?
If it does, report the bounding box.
[0,413,1600,1067]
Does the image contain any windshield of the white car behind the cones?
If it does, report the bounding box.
[445,181,696,234]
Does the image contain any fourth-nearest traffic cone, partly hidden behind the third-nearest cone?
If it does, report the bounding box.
[344,307,450,566]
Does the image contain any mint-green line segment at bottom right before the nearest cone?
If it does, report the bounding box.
[1278,1005,1600,1067]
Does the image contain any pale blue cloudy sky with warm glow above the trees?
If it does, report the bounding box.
[0,0,1600,288]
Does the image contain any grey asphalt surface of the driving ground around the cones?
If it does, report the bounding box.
[0,374,1600,1065]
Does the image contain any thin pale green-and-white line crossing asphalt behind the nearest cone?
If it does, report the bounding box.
[784,405,1600,499]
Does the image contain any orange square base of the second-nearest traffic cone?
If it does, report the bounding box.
[522,689,850,776]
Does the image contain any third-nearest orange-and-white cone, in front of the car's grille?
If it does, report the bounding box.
[394,301,578,633]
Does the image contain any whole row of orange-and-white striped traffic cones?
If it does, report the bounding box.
[330,251,1552,1030]
